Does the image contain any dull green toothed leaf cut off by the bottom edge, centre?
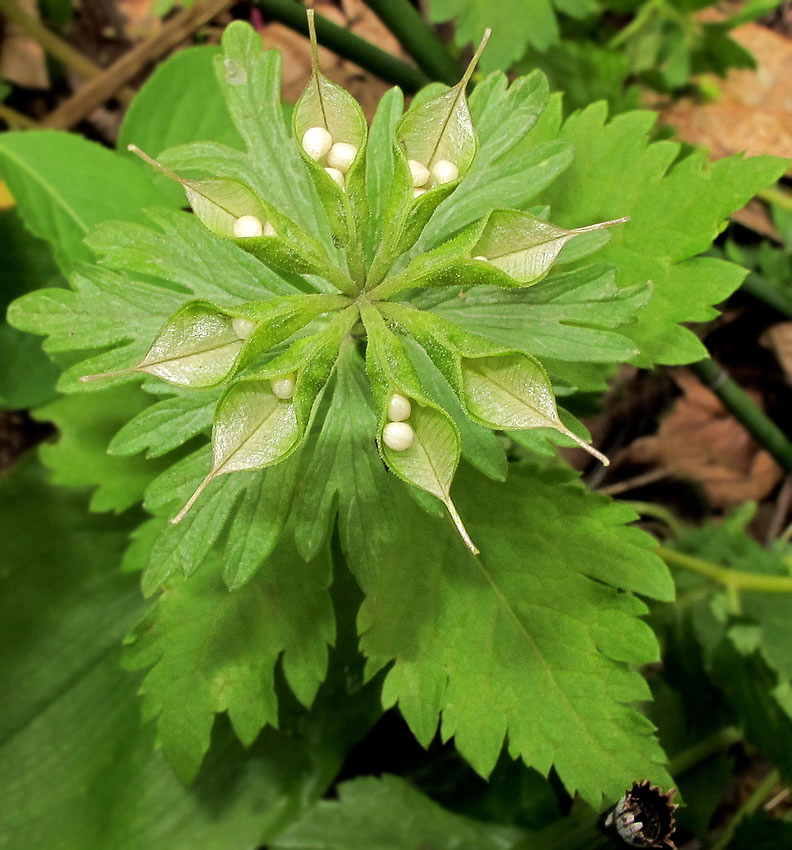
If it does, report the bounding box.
[272,774,522,850]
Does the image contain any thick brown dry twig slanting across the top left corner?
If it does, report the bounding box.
[43,0,231,130]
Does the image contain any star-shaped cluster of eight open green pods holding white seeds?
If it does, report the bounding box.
[82,12,626,552]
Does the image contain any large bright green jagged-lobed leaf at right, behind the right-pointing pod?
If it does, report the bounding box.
[539,104,786,366]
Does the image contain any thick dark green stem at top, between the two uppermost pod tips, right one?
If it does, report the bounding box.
[363,0,461,86]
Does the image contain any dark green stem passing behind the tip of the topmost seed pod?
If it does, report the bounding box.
[256,0,429,92]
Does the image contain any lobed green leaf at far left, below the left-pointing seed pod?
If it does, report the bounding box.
[36,386,168,512]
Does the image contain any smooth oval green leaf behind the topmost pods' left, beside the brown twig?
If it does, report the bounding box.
[117,46,242,156]
